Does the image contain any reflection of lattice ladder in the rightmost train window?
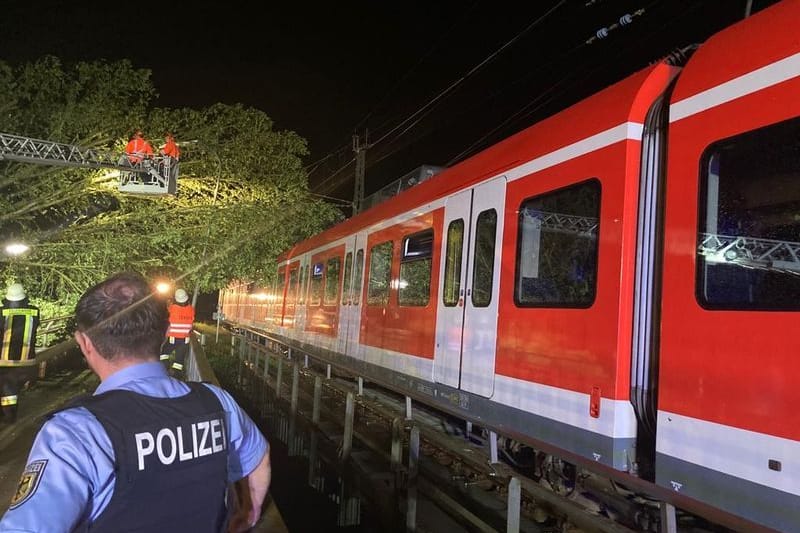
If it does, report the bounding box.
[697,233,800,275]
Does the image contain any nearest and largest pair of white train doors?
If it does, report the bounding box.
[434,177,506,398]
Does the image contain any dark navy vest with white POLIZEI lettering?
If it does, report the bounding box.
[69,383,228,533]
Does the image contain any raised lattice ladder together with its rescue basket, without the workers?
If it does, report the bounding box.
[0,133,178,196]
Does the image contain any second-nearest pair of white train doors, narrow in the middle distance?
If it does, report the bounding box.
[337,235,364,356]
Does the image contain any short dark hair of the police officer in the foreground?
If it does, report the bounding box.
[75,272,169,360]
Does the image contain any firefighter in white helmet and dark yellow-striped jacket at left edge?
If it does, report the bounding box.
[0,283,39,423]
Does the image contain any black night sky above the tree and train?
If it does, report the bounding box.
[0,0,774,206]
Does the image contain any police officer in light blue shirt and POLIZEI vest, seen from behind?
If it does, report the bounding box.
[0,273,270,532]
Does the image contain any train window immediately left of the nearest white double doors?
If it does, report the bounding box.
[397,229,433,307]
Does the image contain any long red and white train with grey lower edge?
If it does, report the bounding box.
[221,0,800,531]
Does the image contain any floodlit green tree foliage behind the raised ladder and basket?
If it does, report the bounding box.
[0,57,341,306]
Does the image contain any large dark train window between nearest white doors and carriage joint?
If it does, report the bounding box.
[514,179,600,307]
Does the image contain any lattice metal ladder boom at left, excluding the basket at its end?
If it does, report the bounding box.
[0,133,134,172]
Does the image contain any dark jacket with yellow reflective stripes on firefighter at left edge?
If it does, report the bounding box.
[0,300,39,366]
